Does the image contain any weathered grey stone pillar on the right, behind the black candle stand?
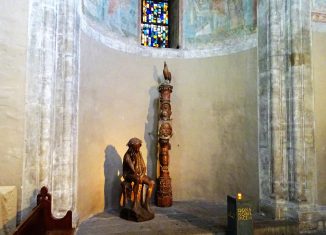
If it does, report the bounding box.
[258,0,326,232]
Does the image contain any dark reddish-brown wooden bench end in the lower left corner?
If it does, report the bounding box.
[14,187,74,235]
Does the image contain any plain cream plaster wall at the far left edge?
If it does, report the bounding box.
[0,0,28,215]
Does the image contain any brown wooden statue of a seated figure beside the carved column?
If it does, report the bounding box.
[120,138,155,221]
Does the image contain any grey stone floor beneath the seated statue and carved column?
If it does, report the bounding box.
[77,202,226,235]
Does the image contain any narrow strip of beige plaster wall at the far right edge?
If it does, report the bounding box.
[312,32,326,205]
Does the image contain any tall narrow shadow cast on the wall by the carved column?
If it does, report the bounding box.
[144,66,160,182]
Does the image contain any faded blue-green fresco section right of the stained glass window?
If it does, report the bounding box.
[182,0,256,48]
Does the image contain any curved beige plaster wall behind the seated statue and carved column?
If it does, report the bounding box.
[77,33,259,220]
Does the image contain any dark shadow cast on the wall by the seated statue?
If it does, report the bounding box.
[104,145,122,211]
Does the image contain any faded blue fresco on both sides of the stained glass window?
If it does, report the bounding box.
[82,0,257,49]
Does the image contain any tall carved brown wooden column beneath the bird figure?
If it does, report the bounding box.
[157,69,173,207]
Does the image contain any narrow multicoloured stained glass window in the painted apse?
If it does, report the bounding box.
[141,0,169,47]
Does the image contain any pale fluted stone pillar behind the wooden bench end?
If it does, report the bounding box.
[22,0,79,218]
